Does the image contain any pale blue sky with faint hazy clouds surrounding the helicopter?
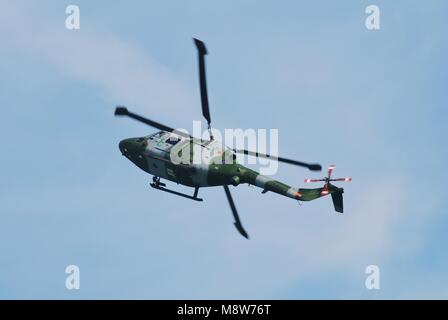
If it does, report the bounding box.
[0,0,448,299]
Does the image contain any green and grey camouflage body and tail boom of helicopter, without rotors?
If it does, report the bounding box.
[119,131,341,201]
